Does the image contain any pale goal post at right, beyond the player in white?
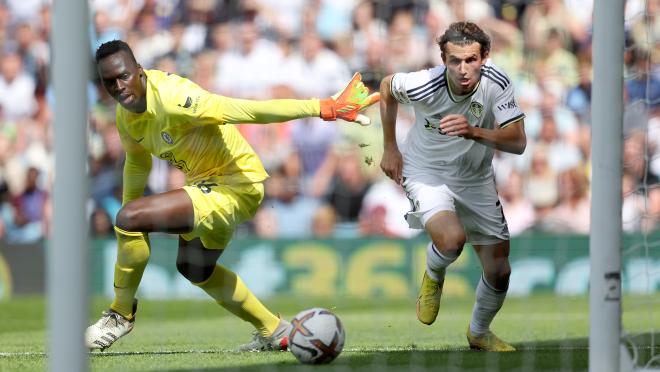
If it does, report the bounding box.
[589,0,625,372]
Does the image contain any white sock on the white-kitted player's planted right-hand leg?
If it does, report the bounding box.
[470,274,506,336]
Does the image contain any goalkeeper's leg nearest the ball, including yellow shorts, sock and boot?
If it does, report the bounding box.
[177,178,290,351]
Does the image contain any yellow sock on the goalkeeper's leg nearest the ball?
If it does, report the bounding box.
[193,265,280,337]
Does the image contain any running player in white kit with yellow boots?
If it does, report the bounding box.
[380,22,527,351]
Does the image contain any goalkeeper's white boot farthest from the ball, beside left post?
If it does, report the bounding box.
[85,300,137,351]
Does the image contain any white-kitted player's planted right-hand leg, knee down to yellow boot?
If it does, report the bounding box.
[467,240,515,351]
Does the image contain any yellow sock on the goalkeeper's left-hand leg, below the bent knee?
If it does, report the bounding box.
[110,227,150,319]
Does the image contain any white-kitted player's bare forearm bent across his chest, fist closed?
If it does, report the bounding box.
[440,114,527,154]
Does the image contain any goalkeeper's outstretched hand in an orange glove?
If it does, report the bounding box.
[321,72,380,125]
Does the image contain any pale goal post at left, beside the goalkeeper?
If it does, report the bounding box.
[46,0,91,372]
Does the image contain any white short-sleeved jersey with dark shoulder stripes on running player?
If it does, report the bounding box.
[392,60,525,186]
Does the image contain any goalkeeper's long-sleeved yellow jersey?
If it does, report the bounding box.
[116,70,320,204]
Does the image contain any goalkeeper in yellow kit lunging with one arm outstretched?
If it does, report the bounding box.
[85,40,379,351]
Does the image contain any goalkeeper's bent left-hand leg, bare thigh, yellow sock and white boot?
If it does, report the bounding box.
[85,189,194,350]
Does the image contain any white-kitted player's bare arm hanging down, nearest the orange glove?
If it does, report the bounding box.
[380,75,403,184]
